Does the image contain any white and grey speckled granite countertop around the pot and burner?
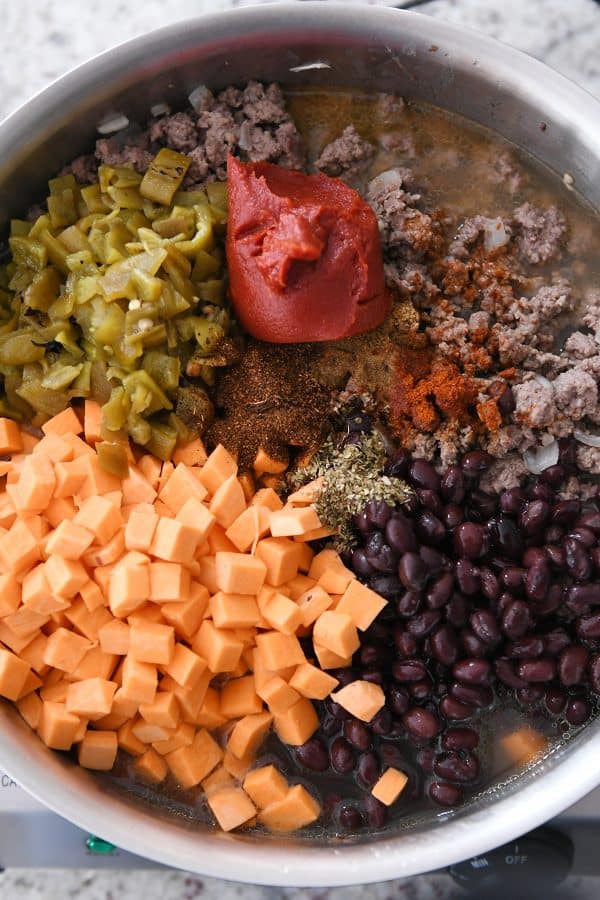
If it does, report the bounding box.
[0,0,600,900]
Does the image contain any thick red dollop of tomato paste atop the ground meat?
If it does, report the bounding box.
[227,156,391,344]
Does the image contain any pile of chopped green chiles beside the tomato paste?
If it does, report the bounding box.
[0,148,232,458]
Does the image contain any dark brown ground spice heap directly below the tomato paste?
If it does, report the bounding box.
[206,340,329,469]
